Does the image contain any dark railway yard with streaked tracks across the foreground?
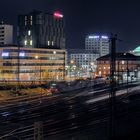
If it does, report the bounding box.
[0,83,140,140]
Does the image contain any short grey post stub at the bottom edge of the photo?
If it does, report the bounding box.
[34,122,43,140]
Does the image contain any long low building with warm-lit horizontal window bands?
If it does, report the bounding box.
[0,46,66,81]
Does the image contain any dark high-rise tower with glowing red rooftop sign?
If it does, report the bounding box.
[18,11,65,49]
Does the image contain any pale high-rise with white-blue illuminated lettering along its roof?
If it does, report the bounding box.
[85,35,109,56]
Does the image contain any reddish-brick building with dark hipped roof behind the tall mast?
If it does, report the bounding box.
[96,53,140,80]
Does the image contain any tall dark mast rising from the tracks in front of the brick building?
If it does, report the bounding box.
[109,34,117,140]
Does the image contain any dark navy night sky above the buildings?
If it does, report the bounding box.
[0,0,140,51]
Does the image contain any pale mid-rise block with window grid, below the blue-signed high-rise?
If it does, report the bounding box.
[67,49,99,77]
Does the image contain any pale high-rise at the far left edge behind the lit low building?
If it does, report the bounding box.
[0,22,13,45]
